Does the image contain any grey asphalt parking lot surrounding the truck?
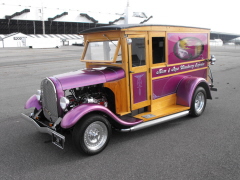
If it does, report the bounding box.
[0,46,240,180]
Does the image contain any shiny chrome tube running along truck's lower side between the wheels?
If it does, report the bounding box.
[120,111,189,132]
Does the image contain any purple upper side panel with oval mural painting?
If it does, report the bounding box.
[167,33,208,64]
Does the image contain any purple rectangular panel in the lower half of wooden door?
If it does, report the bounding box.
[132,72,147,104]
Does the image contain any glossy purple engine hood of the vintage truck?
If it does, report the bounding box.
[50,67,125,90]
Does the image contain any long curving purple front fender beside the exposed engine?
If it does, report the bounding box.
[61,104,143,129]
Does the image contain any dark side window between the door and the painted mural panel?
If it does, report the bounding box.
[152,37,165,64]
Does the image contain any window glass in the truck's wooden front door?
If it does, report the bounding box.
[131,38,146,67]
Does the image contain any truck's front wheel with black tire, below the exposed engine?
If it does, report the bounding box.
[73,114,112,155]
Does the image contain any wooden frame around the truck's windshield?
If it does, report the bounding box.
[81,38,122,63]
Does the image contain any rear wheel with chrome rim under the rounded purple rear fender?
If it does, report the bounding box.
[190,87,207,117]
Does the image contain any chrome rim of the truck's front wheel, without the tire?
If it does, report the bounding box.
[84,121,108,151]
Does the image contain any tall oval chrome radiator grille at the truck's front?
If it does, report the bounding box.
[41,78,58,122]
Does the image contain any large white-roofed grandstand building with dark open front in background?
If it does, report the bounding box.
[0,3,152,34]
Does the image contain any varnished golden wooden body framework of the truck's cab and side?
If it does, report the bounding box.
[82,26,210,121]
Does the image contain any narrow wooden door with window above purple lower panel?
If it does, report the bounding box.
[128,35,150,110]
